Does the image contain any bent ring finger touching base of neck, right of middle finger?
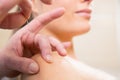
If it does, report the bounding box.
[49,37,68,56]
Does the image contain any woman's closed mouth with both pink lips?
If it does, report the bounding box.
[75,8,92,18]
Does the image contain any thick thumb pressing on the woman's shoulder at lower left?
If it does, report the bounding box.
[5,56,39,74]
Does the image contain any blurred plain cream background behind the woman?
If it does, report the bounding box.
[0,0,120,80]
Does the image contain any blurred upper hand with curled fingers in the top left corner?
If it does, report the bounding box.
[0,0,32,29]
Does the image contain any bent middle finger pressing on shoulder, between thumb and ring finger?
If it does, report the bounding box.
[35,34,52,62]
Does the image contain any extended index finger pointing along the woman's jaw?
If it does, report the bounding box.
[24,8,65,33]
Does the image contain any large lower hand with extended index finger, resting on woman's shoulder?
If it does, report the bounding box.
[0,8,69,76]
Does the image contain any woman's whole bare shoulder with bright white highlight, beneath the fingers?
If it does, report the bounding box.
[22,54,116,80]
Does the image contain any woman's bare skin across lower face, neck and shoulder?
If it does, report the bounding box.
[21,0,116,80]
